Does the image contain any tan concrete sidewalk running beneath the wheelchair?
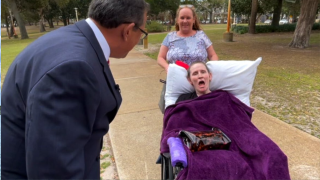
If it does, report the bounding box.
[109,50,320,180]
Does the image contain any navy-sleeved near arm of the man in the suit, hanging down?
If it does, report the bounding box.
[26,61,100,179]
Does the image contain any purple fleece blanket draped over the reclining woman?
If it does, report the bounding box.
[160,90,290,180]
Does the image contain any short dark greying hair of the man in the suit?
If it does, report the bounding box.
[88,0,149,28]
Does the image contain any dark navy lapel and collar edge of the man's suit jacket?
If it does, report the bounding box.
[75,20,122,109]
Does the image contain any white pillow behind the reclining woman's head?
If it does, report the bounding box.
[165,57,262,107]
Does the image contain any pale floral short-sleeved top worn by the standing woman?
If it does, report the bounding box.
[162,30,212,65]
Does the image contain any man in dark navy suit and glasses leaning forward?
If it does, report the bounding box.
[1,0,148,179]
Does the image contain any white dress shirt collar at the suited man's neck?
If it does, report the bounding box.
[86,18,110,63]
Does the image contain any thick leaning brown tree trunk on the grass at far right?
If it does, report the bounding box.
[289,0,319,48]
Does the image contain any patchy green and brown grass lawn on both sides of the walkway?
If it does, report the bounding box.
[1,24,320,138]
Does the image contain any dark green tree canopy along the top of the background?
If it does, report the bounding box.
[1,0,320,46]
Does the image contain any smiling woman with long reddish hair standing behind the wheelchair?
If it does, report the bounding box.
[157,5,219,71]
